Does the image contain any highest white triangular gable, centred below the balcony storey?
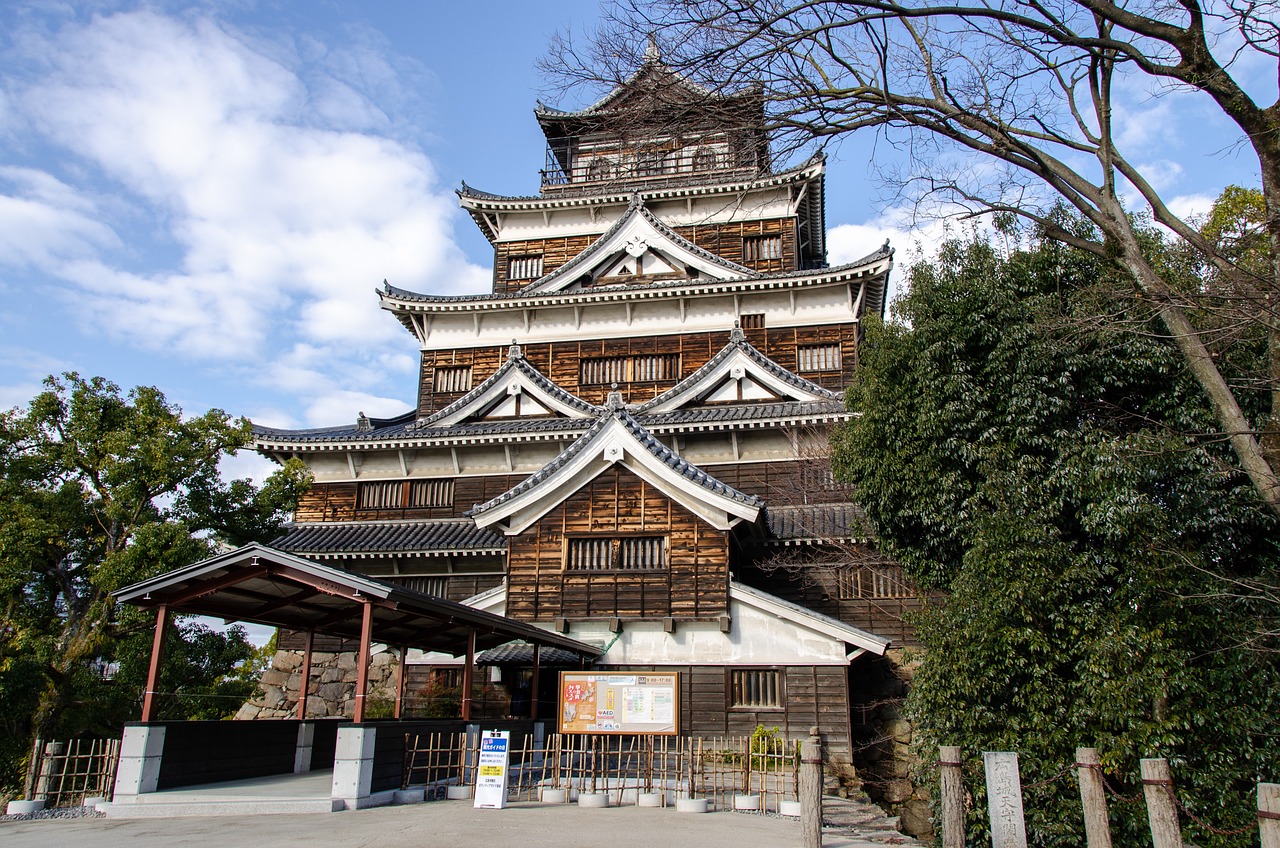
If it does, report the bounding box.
[516,193,759,296]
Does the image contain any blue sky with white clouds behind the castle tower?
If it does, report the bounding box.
[0,0,1257,471]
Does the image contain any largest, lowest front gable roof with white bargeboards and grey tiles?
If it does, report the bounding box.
[467,393,763,535]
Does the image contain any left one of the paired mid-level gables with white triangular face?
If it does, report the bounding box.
[416,343,602,432]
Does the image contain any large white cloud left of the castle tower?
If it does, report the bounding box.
[0,10,489,420]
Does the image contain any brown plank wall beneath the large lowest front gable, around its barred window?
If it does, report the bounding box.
[507,465,728,621]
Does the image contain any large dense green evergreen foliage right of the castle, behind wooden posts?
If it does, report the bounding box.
[835,228,1280,845]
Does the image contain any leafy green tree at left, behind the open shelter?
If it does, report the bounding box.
[0,374,307,787]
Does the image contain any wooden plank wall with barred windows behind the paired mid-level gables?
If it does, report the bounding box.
[419,324,858,415]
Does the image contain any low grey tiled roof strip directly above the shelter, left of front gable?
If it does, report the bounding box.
[271,519,507,556]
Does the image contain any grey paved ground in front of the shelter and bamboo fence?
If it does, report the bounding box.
[0,802,921,848]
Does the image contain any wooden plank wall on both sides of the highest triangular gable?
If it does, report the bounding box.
[493,216,799,295]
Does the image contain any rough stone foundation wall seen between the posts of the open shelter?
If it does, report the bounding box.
[236,649,399,720]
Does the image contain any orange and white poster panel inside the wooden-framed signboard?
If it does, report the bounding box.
[559,671,680,734]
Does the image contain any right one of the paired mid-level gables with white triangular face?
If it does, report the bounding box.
[632,327,840,415]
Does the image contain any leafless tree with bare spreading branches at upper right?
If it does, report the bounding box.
[544,0,1280,514]
